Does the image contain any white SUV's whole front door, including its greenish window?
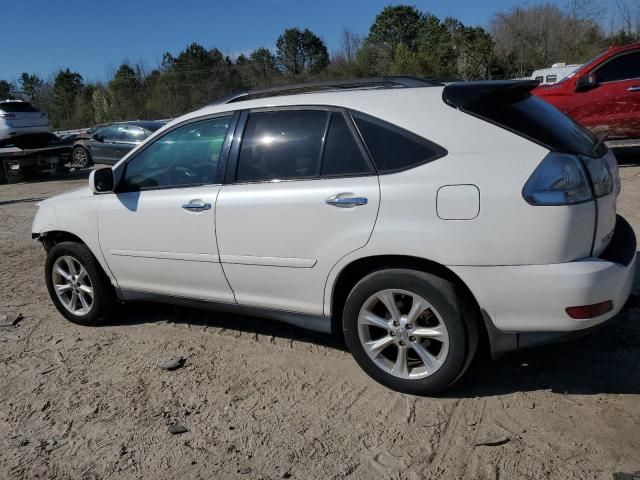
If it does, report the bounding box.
[98,116,234,302]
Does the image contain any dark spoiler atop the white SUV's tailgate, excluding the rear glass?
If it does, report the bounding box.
[442,80,538,112]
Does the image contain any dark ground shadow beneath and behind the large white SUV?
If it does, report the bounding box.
[106,252,640,398]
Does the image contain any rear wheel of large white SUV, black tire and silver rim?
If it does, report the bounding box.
[342,269,478,395]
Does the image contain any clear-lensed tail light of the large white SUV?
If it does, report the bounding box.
[522,152,620,205]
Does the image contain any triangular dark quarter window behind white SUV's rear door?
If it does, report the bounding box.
[353,113,447,173]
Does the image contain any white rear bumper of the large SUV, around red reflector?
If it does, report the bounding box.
[451,216,636,351]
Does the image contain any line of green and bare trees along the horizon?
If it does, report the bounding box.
[0,0,640,129]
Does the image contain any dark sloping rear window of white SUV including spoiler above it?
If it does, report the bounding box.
[443,82,606,157]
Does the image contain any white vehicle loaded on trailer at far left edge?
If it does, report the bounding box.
[0,100,51,140]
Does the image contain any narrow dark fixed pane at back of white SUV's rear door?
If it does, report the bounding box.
[320,113,372,176]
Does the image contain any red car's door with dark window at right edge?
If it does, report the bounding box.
[567,51,640,139]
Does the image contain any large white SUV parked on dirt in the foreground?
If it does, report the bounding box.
[33,77,636,394]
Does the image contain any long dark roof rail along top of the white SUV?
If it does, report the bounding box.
[211,76,442,105]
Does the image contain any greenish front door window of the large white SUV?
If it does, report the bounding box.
[123,116,231,191]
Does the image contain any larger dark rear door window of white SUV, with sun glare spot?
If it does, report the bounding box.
[236,110,329,182]
